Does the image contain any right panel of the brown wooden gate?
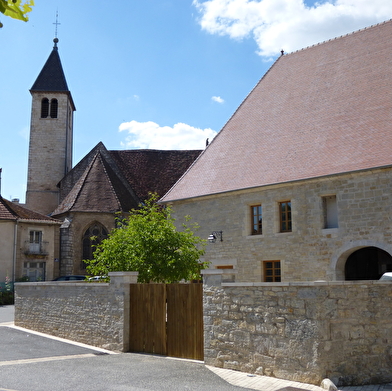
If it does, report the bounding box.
[166,284,204,360]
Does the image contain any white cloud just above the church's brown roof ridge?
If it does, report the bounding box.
[119,121,217,149]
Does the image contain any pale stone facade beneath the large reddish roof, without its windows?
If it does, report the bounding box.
[172,168,392,282]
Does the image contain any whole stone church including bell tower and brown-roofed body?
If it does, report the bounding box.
[26,38,201,275]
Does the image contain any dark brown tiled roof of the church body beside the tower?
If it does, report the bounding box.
[52,142,201,216]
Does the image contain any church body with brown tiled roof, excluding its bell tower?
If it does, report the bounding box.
[51,143,200,274]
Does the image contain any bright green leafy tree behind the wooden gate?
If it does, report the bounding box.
[84,194,207,283]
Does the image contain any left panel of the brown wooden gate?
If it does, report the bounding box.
[129,284,167,355]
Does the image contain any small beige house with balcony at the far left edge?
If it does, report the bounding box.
[0,196,61,282]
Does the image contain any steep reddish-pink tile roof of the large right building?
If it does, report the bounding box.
[162,20,392,202]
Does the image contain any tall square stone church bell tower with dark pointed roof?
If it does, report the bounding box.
[26,38,75,215]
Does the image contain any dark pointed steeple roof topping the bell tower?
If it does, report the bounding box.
[30,38,73,108]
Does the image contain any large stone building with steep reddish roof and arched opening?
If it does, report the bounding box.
[161,20,392,282]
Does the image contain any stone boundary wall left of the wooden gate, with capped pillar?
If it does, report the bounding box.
[15,272,137,351]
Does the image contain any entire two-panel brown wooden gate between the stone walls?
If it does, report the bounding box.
[129,283,204,360]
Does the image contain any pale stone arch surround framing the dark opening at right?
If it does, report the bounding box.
[329,240,392,281]
